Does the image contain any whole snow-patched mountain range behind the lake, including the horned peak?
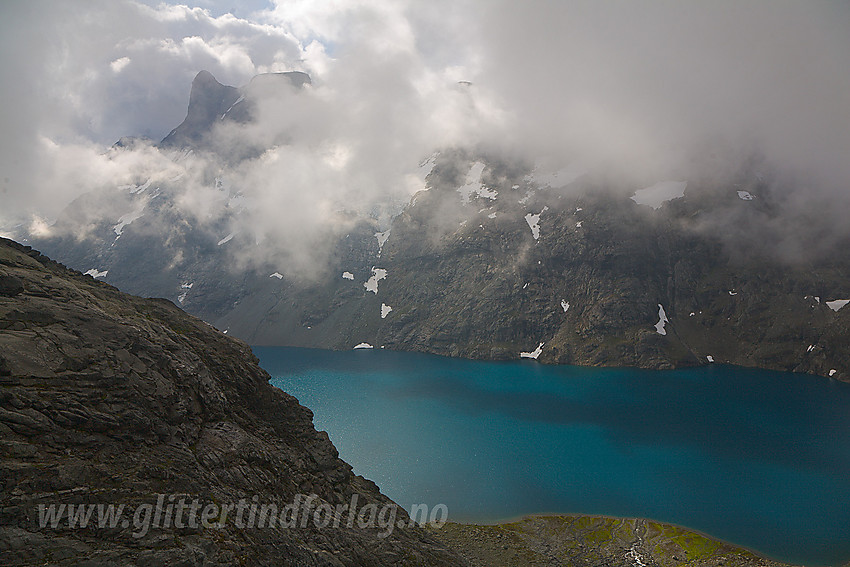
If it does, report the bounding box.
[24,72,850,380]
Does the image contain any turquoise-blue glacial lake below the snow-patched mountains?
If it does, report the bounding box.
[254,347,850,565]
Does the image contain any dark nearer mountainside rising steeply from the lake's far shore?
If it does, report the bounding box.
[211,155,850,380]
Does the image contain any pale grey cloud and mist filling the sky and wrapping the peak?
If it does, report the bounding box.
[0,1,850,267]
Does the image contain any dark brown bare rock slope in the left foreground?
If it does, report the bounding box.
[0,239,463,566]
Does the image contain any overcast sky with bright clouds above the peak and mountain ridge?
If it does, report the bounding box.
[0,0,850,262]
